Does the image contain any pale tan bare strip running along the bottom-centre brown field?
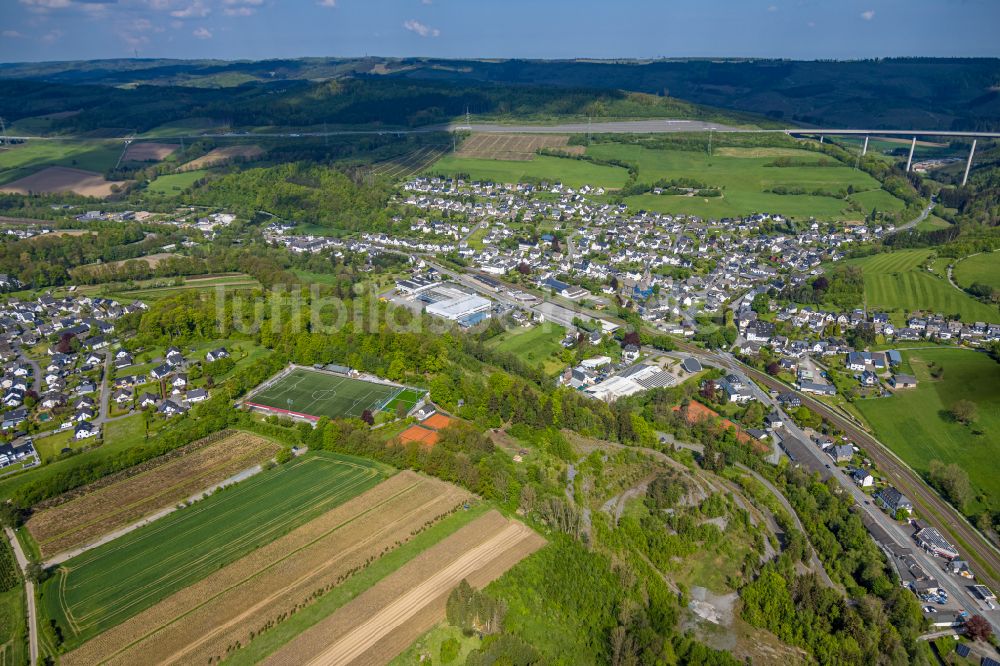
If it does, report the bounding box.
[306,523,534,666]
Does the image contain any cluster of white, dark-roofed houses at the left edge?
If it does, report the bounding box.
[0,291,229,468]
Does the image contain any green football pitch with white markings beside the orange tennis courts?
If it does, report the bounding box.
[250,368,415,418]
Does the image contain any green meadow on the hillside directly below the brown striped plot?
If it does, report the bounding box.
[426,155,628,188]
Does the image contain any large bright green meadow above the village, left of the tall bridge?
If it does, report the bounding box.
[587,143,902,220]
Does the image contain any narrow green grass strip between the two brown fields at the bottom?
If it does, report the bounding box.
[226,504,492,666]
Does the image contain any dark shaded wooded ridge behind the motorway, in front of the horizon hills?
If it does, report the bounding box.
[0,77,749,134]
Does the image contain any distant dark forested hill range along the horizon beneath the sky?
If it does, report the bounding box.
[0,58,1000,130]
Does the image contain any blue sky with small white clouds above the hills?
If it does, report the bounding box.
[0,0,1000,62]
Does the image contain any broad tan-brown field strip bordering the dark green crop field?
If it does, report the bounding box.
[62,472,470,664]
